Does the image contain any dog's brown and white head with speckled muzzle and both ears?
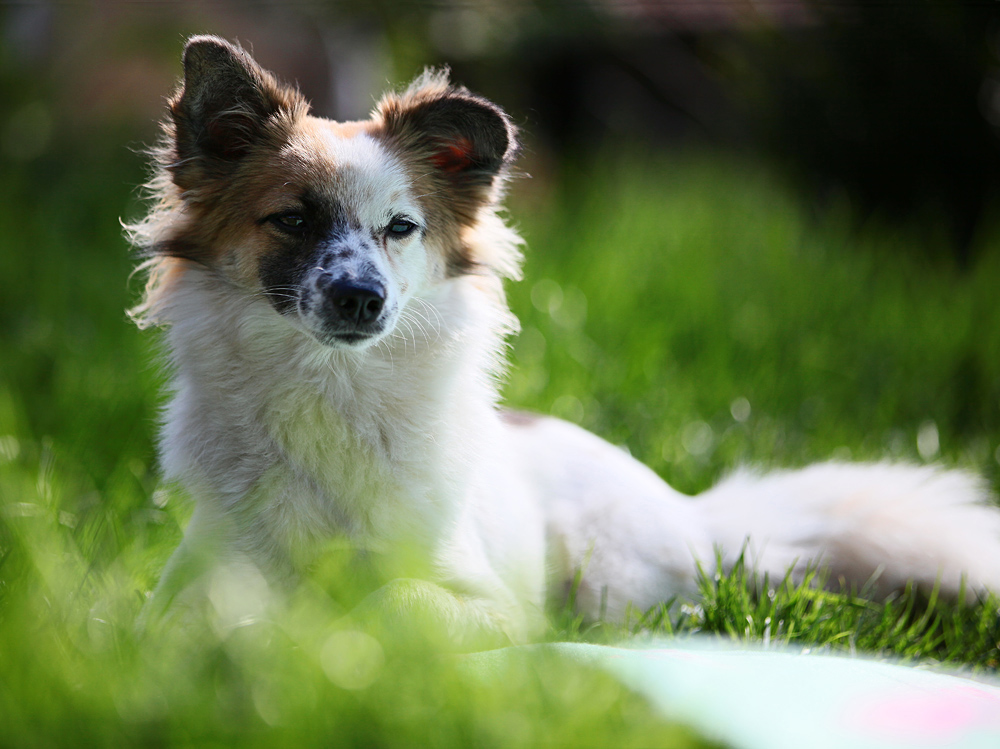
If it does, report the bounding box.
[147,36,517,348]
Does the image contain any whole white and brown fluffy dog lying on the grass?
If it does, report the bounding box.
[128,36,1000,648]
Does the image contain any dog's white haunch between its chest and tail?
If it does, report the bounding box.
[508,418,712,620]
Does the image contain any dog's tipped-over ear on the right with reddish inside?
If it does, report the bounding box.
[375,71,518,224]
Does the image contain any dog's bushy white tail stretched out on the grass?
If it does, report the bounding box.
[698,463,1000,598]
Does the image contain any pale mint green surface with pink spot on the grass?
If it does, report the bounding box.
[470,641,1000,749]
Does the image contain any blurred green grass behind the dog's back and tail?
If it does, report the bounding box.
[507,153,1000,492]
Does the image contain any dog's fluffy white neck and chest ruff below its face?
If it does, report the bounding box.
[155,254,514,558]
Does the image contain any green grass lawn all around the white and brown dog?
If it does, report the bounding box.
[0,140,1000,747]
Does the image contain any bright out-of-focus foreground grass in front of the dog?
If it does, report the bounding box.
[0,482,707,749]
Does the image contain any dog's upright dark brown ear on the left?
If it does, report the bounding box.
[167,36,308,190]
